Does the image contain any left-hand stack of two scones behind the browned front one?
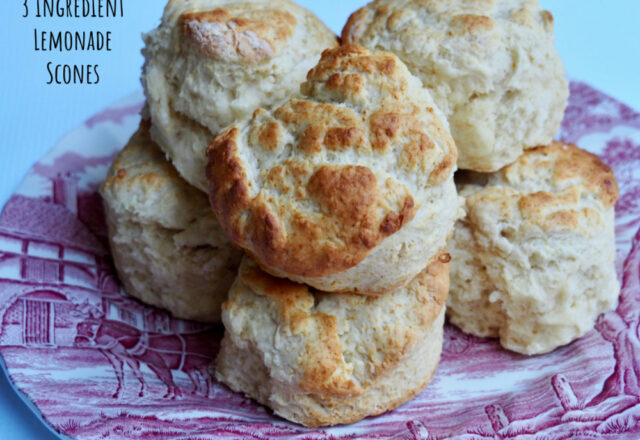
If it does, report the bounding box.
[101,0,338,323]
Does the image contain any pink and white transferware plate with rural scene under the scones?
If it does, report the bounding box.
[0,82,640,440]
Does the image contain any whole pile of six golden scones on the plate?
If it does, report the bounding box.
[101,0,618,427]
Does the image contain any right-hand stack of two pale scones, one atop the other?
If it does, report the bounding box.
[342,0,619,354]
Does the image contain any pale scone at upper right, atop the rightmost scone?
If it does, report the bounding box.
[342,0,569,172]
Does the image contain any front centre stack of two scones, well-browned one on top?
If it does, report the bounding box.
[207,46,459,426]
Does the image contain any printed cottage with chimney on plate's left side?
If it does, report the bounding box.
[0,174,120,347]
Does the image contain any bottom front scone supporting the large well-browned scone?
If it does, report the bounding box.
[216,254,449,427]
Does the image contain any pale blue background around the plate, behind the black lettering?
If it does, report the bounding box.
[0,0,640,440]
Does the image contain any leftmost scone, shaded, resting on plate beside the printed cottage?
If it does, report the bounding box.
[100,121,242,323]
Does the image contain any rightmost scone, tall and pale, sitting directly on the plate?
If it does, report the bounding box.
[447,142,619,354]
